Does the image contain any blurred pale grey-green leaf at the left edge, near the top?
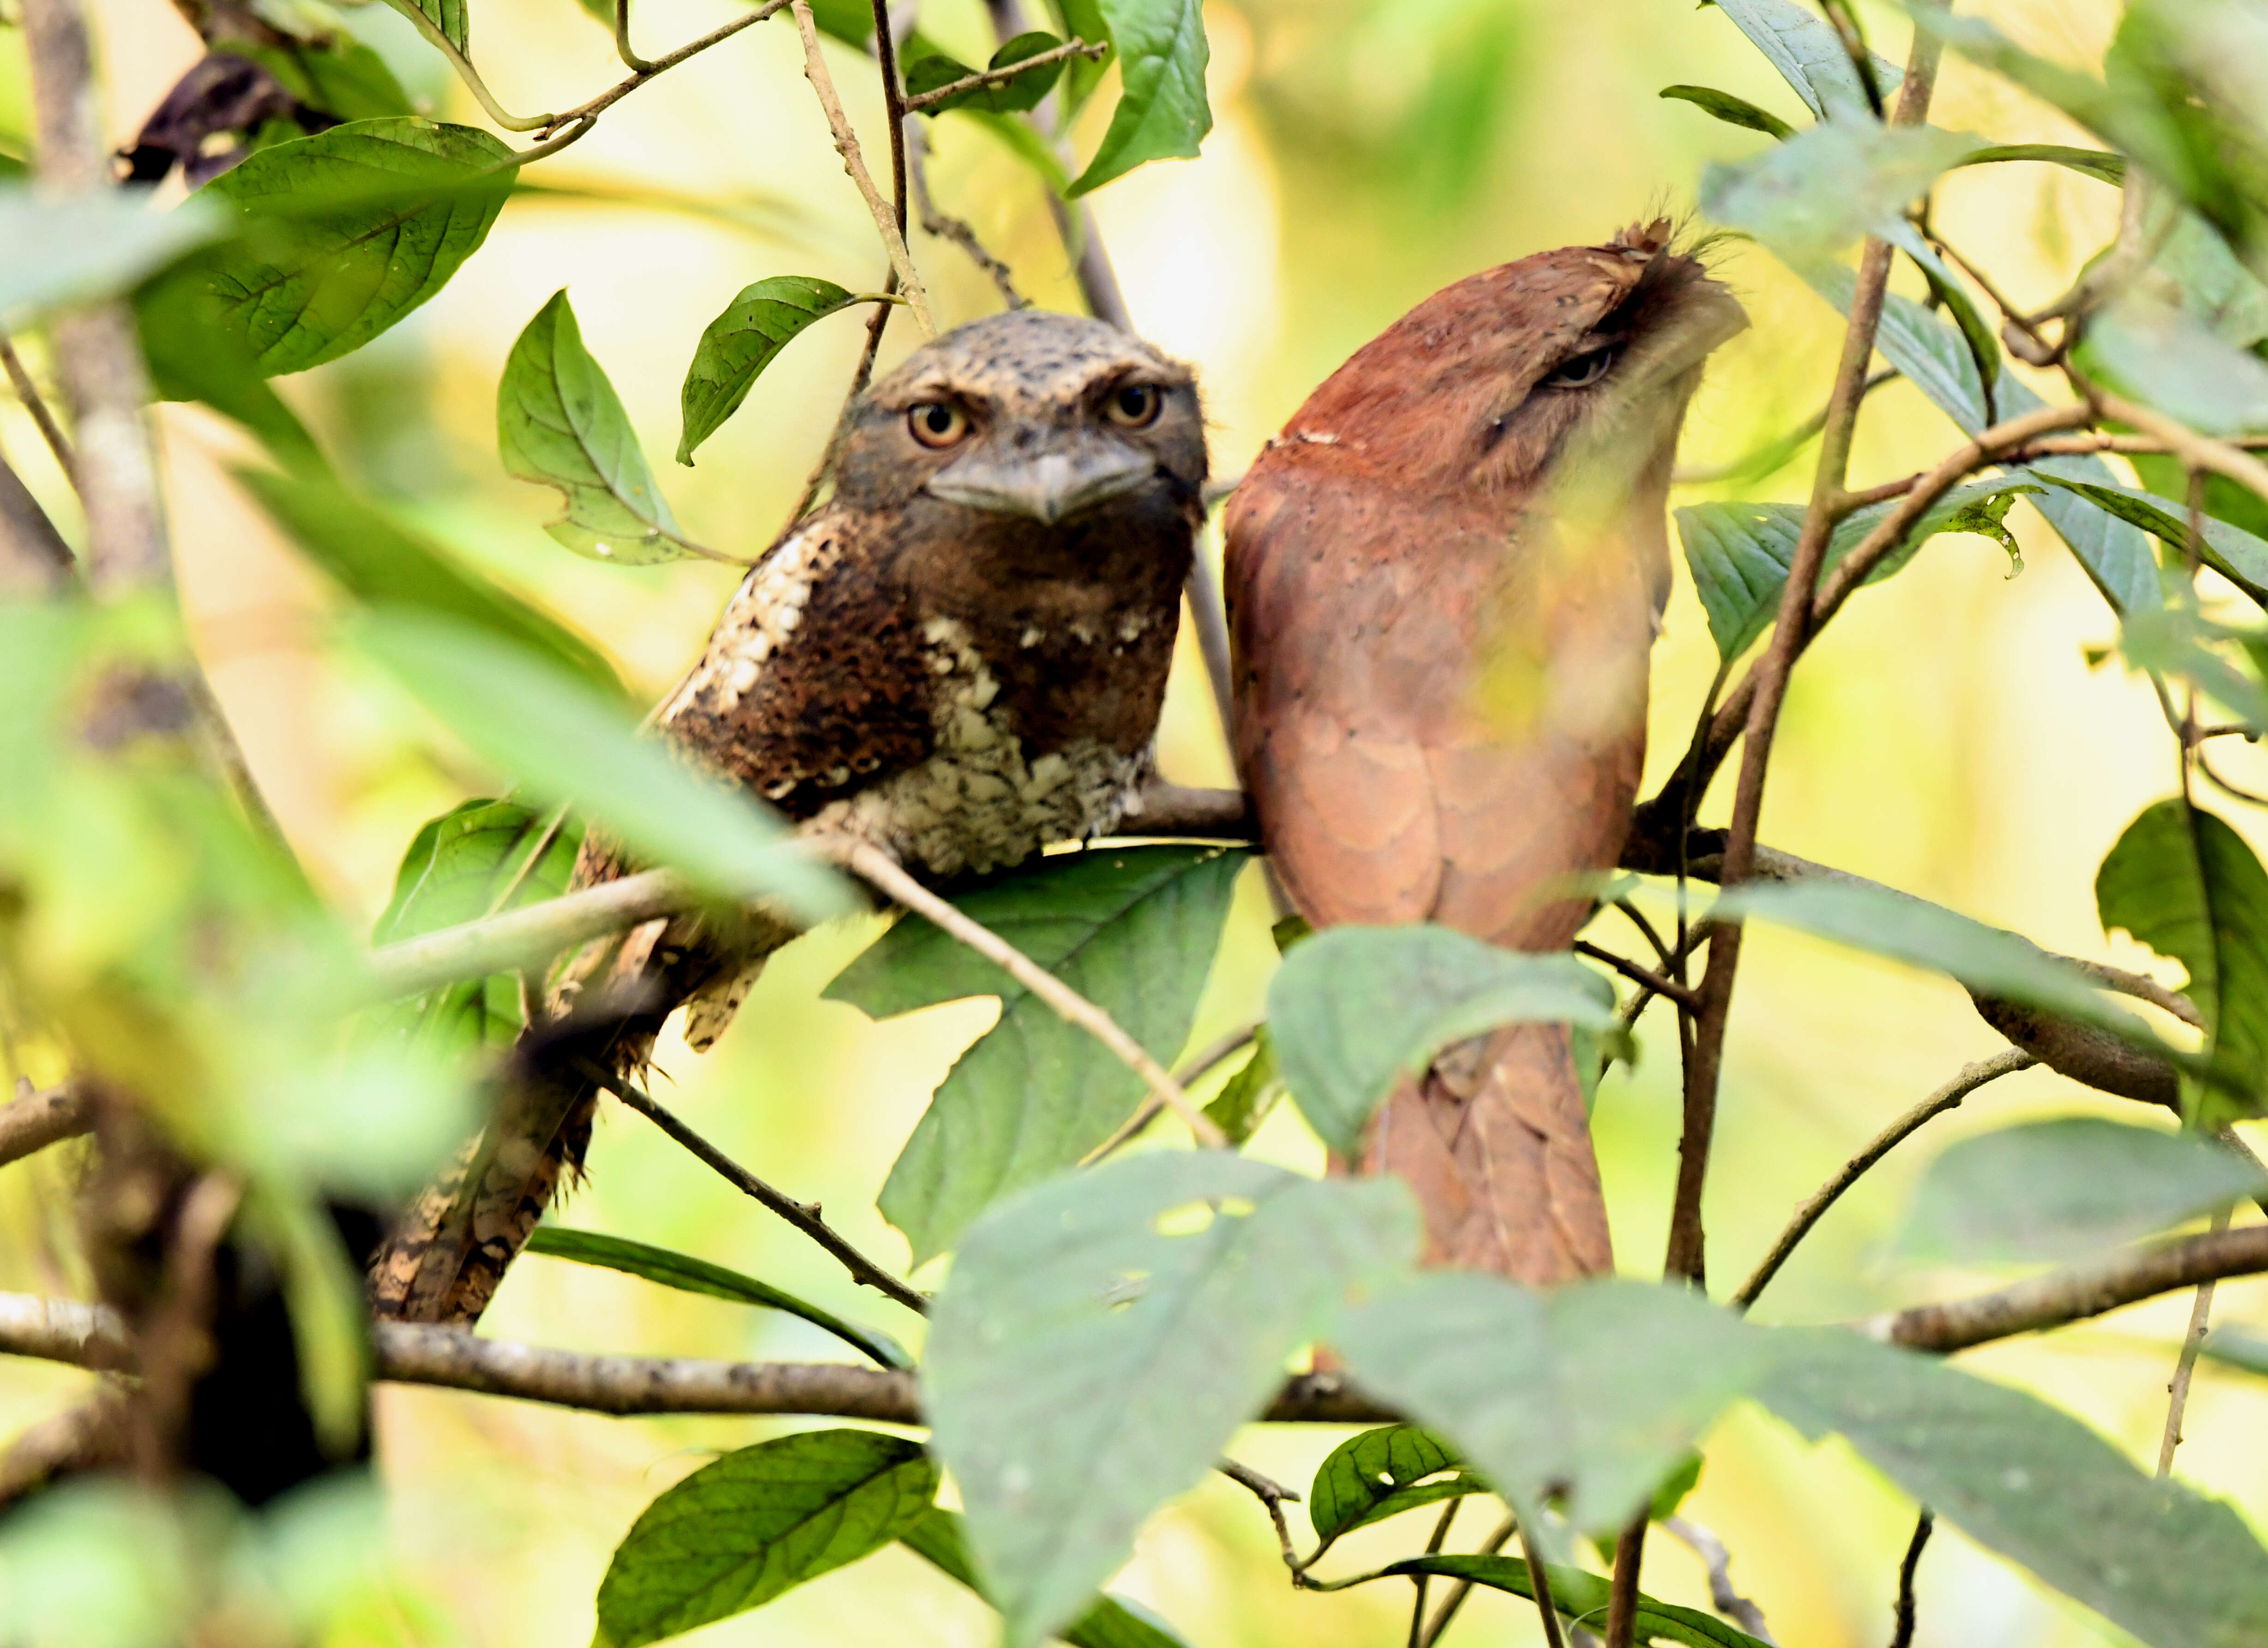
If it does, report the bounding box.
[0,184,227,326]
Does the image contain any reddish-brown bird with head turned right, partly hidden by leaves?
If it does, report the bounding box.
[1227,224,1744,1285]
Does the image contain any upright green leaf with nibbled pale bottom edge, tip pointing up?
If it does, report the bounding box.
[497,297,708,567]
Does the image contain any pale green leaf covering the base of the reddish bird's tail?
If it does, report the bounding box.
[1268,925,1615,1156]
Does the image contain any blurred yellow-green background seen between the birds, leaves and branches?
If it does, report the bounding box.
[0,0,2268,1648]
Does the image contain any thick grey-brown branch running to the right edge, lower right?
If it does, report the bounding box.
[1860,1224,2268,1353]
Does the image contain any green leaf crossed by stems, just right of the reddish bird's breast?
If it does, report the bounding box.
[1676,480,2039,659]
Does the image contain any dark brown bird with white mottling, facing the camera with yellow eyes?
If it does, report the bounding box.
[372,311,1204,1322]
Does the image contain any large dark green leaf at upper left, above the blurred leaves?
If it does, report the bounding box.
[197,118,512,376]
